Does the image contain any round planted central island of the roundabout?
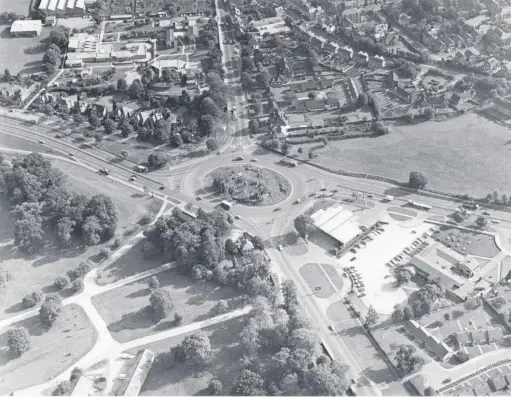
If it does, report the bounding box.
[204,164,292,206]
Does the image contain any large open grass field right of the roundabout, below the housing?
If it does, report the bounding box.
[304,113,511,196]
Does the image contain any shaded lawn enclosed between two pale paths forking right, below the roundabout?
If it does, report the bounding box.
[92,269,242,342]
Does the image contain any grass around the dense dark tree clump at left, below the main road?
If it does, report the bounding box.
[0,160,161,319]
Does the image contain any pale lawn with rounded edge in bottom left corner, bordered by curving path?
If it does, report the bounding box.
[0,305,96,394]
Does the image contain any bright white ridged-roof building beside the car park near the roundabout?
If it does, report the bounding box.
[311,205,361,245]
